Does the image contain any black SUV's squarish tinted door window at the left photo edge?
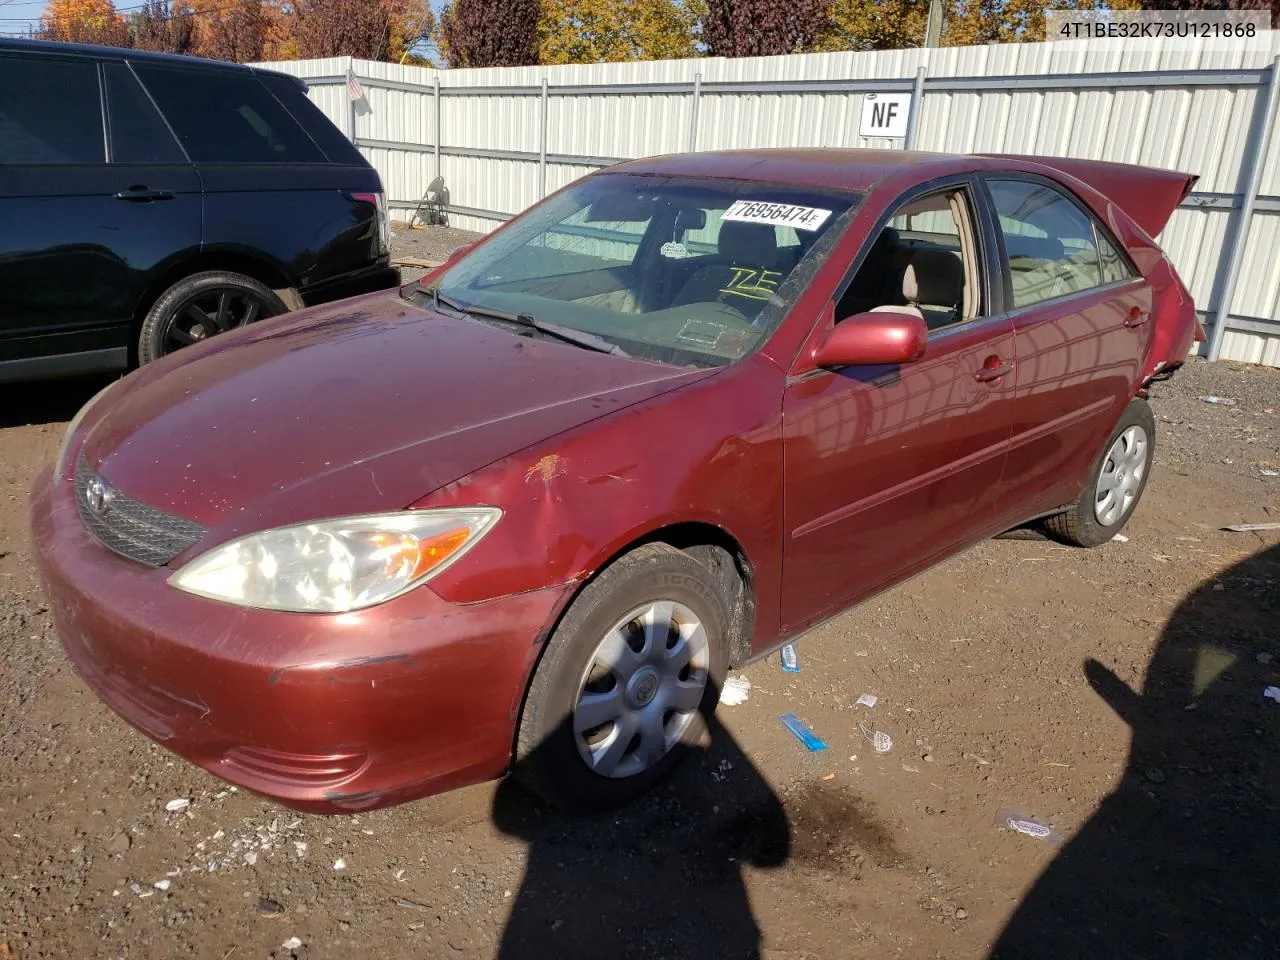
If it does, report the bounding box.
[0,56,106,165]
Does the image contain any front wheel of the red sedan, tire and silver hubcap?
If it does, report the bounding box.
[515,544,730,813]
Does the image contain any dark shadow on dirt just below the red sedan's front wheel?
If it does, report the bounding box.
[493,719,791,960]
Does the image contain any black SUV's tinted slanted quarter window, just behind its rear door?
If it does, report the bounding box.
[133,63,325,164]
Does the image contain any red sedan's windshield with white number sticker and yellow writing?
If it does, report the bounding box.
[436,174,860,366]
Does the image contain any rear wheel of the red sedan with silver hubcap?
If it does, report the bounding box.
[1044,398,1156,547]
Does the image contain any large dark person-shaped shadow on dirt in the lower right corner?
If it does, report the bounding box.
[991,547,1280,960]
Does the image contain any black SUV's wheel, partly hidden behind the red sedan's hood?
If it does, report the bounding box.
[138,270,288,364]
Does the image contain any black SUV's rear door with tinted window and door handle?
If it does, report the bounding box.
[0,52,200,379]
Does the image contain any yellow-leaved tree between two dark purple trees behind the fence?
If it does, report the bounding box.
[538,0,705,64]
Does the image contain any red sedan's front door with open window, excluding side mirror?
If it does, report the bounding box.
[782,178,1014,631]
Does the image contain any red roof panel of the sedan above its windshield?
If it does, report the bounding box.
[608,147,992,191]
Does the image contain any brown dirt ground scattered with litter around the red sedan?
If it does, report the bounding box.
[0,232,1280,960]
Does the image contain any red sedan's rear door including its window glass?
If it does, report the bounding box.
[986,174,1152,522]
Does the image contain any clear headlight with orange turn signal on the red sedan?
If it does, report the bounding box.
[169,507,502,613]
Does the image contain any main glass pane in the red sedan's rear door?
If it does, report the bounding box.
[987,180,1103,307]
